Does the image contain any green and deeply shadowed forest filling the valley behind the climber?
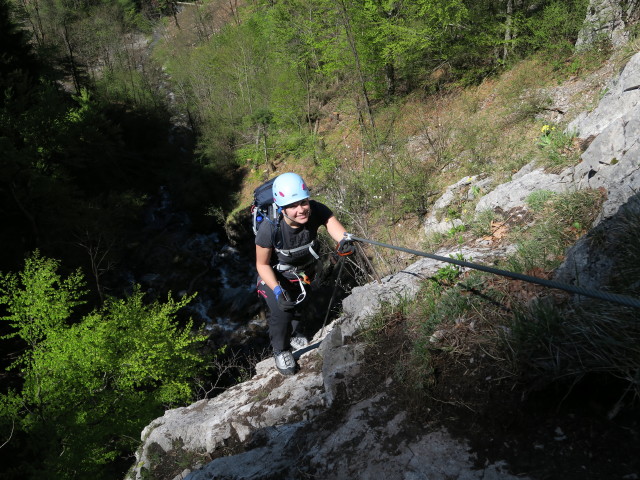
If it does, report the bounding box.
[0,0,604,479]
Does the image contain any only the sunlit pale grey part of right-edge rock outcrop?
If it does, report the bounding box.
[460,53,640,222]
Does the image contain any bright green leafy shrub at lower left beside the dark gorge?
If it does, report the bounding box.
[0,252,203,478]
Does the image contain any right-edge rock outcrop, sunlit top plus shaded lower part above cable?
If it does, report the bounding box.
[464,53,640,289]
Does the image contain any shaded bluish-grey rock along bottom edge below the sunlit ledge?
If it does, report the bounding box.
[182,394,521,480]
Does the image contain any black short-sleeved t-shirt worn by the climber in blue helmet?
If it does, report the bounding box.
[256,200,333,265]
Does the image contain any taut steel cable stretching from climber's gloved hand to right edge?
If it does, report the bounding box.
[349,235,640,308]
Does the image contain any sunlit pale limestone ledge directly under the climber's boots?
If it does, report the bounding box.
[127,351,325,480]
